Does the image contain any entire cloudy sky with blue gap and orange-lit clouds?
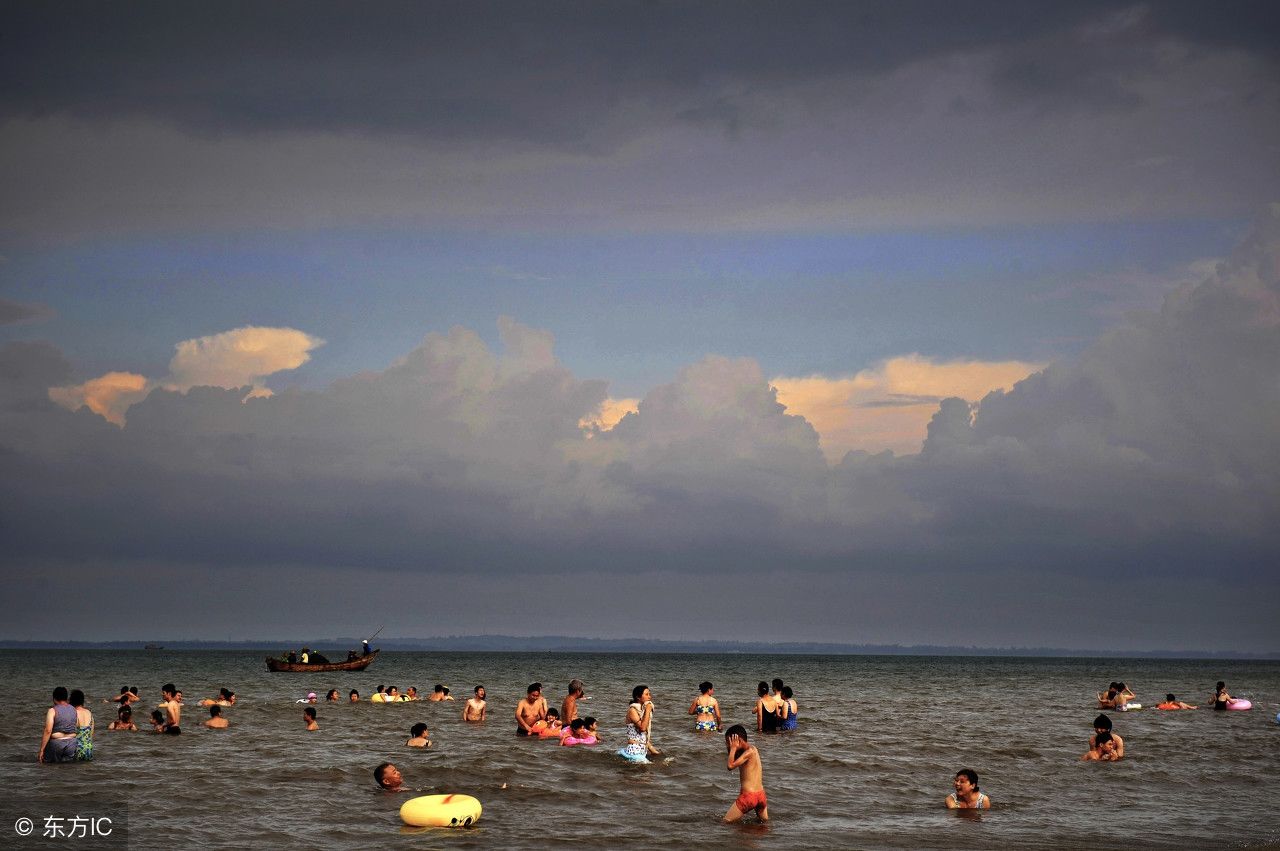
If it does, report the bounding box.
[0,0,1280,653]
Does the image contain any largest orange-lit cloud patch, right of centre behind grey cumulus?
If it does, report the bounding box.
[772,354,1044,461]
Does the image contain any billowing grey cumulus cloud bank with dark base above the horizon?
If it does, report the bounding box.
[0,209,1280,593]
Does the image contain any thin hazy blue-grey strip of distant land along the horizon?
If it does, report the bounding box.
[0,635,1280,662]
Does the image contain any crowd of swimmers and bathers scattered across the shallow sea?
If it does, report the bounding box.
[37,670,1249,822]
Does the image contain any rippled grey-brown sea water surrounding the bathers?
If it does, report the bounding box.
[0,650,1280,848]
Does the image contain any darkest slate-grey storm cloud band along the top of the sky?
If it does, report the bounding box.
[0,1,1277,148]
